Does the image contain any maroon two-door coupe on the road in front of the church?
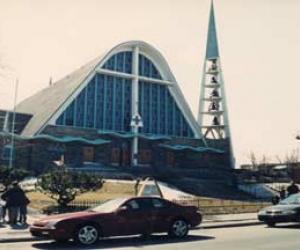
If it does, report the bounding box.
[30,197,202,245]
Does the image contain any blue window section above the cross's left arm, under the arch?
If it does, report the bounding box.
[102,51,132,74]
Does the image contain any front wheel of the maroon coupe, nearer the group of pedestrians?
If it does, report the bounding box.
[75,224,100,245]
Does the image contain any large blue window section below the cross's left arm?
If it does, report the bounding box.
[56,74,132,132]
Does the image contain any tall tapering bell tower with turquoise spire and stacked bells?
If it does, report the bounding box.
[198,1,234,167]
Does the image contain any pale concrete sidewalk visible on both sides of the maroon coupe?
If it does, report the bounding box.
[0,213,261,244]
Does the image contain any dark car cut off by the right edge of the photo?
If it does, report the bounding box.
[258,194,300,227]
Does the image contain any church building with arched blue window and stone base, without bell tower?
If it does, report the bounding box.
[0,3,232,178]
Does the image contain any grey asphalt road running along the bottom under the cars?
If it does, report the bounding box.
[0,224,300,250]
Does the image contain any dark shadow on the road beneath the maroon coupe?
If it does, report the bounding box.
[32,235,215,249]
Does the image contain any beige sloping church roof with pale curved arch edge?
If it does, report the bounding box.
[16,41,201,138]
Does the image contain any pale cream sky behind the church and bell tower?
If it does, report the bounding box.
[0,0,300,163]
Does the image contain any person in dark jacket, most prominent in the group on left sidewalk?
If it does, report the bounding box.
[1,181,25,225]
